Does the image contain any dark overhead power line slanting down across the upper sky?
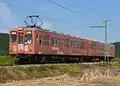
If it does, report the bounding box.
[47,0,100,21]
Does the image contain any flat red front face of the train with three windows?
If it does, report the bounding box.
[9,27,35,54]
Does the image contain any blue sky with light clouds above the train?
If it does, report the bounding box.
[0,0,120,43]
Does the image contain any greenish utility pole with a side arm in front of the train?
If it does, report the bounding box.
[90,20,110,62]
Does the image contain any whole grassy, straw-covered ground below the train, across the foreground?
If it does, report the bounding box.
[0,64,120,86]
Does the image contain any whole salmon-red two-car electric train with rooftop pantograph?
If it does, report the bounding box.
[9,16,115,63]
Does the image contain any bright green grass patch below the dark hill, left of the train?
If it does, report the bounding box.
[0,56,17,65]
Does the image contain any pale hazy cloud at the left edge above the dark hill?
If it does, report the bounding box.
[0,3,17,32]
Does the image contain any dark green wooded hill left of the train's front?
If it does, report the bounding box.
[0,33,9,55]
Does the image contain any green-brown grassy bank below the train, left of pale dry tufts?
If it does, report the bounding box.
[0,64,89,83]
